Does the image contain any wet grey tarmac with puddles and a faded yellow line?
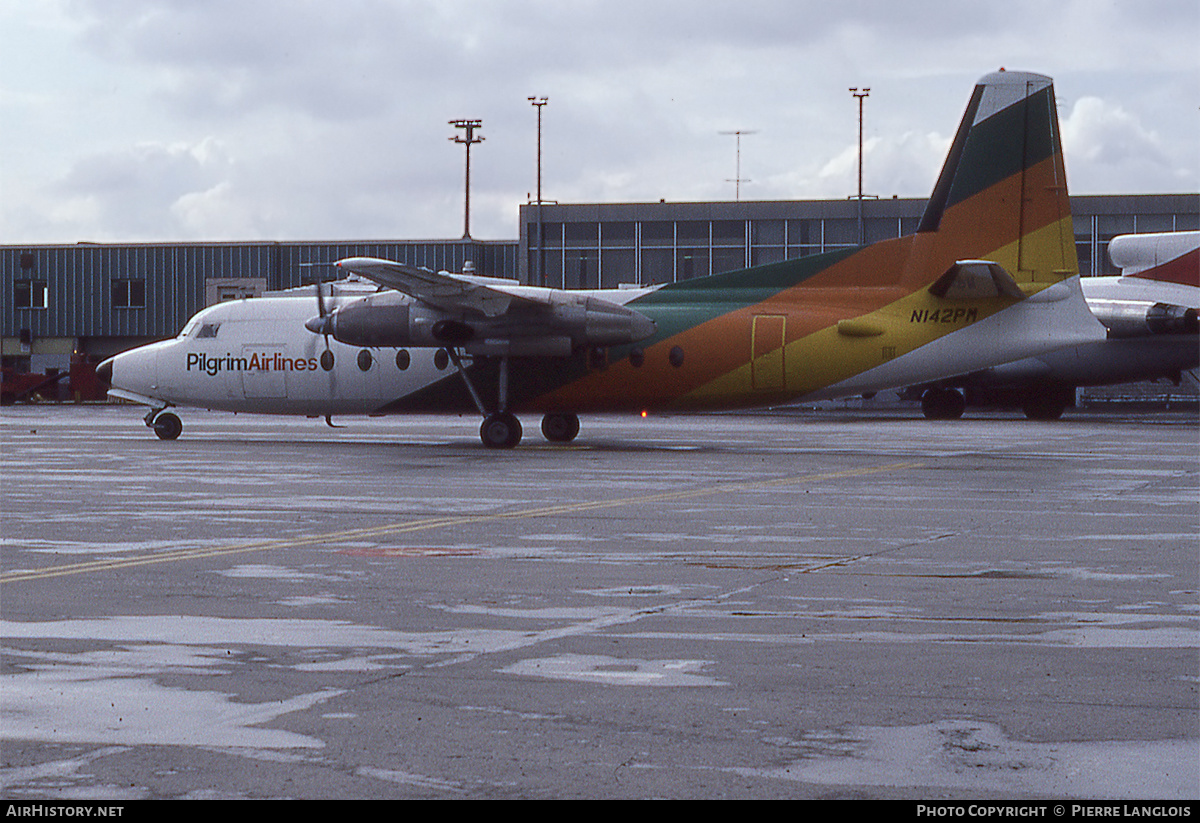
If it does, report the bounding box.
[0,407,1200,800]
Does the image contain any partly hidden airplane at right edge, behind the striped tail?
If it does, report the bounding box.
[906,232,1200,420]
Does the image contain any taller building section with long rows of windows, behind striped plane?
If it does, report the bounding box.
[520,194,1200,289]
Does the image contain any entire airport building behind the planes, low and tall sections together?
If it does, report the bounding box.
[0,194,1200,376]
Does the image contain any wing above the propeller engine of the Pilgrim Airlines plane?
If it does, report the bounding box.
[336,257,537,317]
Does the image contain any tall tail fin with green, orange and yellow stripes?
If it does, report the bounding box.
[918,70,1079,290]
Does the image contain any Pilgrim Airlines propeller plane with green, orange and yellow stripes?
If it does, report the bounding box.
[97,70,1104,449]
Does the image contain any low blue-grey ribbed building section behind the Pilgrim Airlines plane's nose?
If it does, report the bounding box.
[0,240,517,372]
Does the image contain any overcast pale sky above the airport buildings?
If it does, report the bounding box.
[0,0,1200,244]
